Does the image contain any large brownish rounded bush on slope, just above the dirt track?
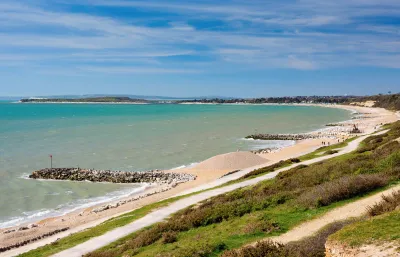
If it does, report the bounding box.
[298,174,389,207]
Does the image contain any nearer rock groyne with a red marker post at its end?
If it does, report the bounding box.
[29,168,196,185]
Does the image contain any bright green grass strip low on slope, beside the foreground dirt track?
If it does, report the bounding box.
[90,201,338,256]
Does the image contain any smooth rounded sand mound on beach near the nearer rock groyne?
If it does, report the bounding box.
[193,152,269,170]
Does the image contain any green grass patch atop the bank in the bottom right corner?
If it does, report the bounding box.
[330,211,400,247]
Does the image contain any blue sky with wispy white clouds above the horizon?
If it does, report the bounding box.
[0,0,400,97]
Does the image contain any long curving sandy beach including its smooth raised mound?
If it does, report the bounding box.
[0,102,398,253]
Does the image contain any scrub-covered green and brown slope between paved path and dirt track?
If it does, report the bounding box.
[82,122,400,257]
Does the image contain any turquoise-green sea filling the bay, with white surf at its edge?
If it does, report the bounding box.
[0,102,351,227]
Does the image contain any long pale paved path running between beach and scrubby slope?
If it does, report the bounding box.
[53,130,387,257]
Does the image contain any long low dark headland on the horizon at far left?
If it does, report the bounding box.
[21,96,148,103]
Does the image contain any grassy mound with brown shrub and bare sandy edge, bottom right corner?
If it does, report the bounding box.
[325,191,400,256]
